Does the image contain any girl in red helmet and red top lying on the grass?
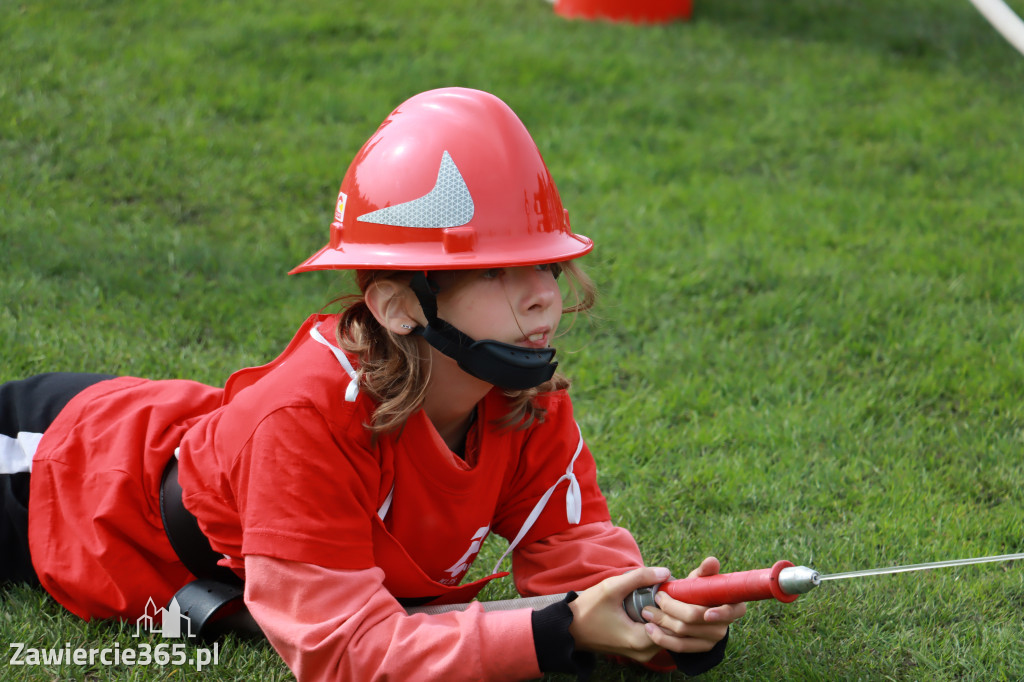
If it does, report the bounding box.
[0,88,745,681]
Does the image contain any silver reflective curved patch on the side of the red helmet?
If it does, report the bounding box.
[357,152,475,227]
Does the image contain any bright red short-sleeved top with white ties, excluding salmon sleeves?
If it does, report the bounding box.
[30,315,608,619]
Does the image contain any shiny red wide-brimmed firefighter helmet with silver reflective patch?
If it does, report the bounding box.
[292,88,593,273]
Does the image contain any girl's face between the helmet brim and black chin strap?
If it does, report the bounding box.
[435,265,562,348]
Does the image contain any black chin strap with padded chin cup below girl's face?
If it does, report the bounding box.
[410,272,558,390]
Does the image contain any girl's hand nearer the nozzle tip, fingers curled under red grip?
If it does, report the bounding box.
[638,556,746,653]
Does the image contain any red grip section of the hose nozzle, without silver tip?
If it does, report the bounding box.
[658,561,800,606]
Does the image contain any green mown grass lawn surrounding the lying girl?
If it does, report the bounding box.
[0,0,1024,681]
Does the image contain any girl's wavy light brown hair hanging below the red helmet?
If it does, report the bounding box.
[335,261,597,436]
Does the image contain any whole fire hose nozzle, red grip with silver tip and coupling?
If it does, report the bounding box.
[623,561,821,623]
